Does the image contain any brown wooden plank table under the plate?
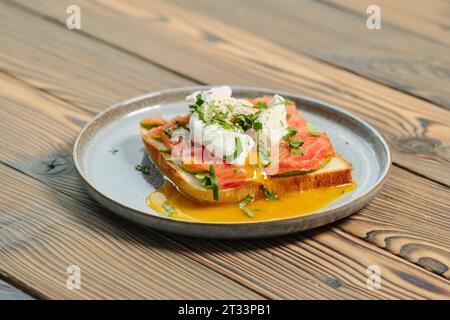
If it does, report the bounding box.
[0,0,450,299]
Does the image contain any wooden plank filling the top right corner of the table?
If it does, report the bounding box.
[321,0,450,46]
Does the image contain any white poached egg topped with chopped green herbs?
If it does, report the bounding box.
[186,86,287,165]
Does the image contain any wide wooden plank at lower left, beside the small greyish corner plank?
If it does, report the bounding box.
[0,165,261,299]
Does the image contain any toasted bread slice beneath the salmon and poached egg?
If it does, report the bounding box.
[141,129,352,203]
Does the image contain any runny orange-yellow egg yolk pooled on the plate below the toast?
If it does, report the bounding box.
[147,182,356,222]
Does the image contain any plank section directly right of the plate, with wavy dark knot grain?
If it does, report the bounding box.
[336,167,450,279]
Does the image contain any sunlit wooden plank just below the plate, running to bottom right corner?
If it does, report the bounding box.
[171,228,450,299]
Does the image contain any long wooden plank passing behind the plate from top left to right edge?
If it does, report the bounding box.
[7,0,450,185]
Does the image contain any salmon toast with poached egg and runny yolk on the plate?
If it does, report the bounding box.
[140,86,353,220]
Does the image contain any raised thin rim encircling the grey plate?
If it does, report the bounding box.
[72,84,392,227]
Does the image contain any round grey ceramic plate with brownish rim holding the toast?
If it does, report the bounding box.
[73,86,391,238]
